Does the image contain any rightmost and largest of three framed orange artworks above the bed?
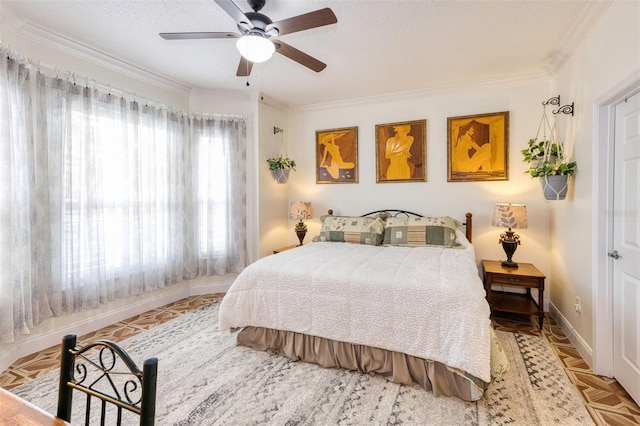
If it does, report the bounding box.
[447,111,509,182]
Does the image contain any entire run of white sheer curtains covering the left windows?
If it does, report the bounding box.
[0,50,246,343]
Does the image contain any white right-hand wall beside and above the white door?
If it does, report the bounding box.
[551,1,640,366]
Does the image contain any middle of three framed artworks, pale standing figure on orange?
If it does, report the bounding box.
[376,120,427,183]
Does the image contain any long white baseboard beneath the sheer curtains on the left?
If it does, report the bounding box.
[0,274,237,372]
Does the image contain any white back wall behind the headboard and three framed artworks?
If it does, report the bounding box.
[288,78,553,296]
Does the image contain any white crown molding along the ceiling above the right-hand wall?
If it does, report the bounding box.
[545,0,613,76]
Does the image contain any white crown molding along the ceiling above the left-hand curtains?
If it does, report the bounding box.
[13,23,191,95]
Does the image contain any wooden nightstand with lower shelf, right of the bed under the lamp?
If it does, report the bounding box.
[482,260,546,330]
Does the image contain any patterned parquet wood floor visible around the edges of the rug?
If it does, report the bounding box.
[0,294,640,426]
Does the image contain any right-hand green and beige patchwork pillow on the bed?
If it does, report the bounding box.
[383,216,461,247]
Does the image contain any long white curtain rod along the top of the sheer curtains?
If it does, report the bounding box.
[0,41,247,121]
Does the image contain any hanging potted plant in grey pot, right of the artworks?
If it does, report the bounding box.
[521,139,577,200]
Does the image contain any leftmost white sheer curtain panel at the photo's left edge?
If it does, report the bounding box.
[0,53,37,342]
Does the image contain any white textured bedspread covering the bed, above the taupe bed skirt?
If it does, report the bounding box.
[219,236,491,382]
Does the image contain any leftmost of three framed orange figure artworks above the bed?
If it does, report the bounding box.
[316,127,358,183]
